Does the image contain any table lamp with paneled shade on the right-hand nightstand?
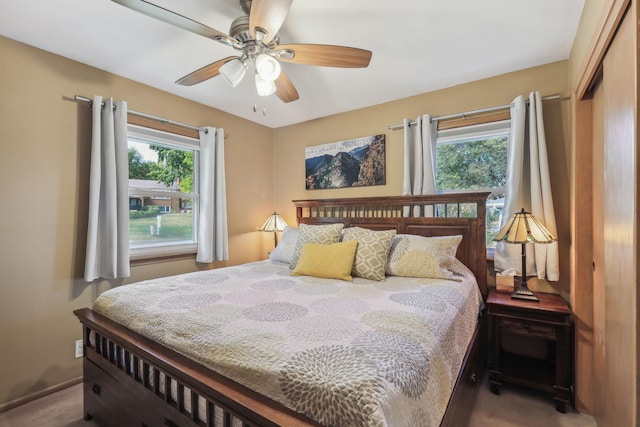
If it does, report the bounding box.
[493,209,556,301]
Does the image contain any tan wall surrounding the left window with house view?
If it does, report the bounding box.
[0,37,273,404]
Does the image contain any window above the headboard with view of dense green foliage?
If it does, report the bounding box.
[436,120,511,248]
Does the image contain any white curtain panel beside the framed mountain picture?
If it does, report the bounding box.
[402,114,438,216]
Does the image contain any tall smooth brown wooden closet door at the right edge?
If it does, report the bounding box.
[592,8,637,426]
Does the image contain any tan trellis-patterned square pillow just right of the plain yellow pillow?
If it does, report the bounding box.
[342,227,396,280]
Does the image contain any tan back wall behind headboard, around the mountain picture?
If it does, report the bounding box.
[274,61,571,298]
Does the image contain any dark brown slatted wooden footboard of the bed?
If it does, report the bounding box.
[74,308,318,427]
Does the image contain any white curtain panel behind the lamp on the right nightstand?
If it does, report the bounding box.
[494,92,559,281]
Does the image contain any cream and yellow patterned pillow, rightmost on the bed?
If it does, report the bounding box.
[386,234,462,281]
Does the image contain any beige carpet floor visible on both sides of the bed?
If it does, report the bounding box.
[0,381,596,427]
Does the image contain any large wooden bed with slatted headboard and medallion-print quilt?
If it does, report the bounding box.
[74,193,488,426]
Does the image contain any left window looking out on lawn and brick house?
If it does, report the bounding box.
[128,125,200,258]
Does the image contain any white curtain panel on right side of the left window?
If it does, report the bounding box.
[196,127,229,263]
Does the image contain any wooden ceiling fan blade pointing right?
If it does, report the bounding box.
[275,44,371,68]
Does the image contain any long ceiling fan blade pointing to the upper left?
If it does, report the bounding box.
[111,0,240,47]
